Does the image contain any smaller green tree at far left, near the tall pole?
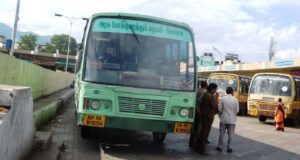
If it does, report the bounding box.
[19,34,38,50]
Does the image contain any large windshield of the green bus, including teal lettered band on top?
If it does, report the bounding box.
[84,18,195,91]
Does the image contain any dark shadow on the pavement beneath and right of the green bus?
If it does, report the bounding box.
[83,124,300,160]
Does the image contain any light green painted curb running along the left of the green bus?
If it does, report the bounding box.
[33,90,74,129]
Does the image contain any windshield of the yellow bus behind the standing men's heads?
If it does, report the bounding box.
[208,75,238,92]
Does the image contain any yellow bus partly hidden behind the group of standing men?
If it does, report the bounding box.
[208,73,251,115]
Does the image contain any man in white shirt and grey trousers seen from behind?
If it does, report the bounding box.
[216,87,239,153]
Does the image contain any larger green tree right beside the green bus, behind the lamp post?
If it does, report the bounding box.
[44,34,77,55]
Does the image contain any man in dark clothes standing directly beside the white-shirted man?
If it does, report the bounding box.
[195,83,219,155]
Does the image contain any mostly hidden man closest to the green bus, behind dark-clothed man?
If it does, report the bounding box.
[189,81,207,147]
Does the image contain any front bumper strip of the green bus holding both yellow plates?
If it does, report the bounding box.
[77,114,192,133]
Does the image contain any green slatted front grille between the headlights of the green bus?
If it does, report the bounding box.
[118,97,166,116]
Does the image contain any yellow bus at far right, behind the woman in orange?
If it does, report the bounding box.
[248,73,300,124]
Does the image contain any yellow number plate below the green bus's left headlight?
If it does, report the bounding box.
[83,114,105,127]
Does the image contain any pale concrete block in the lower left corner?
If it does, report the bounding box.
[0,85,34,160]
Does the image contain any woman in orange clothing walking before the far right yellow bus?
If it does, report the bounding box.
[274,98,285,132]
